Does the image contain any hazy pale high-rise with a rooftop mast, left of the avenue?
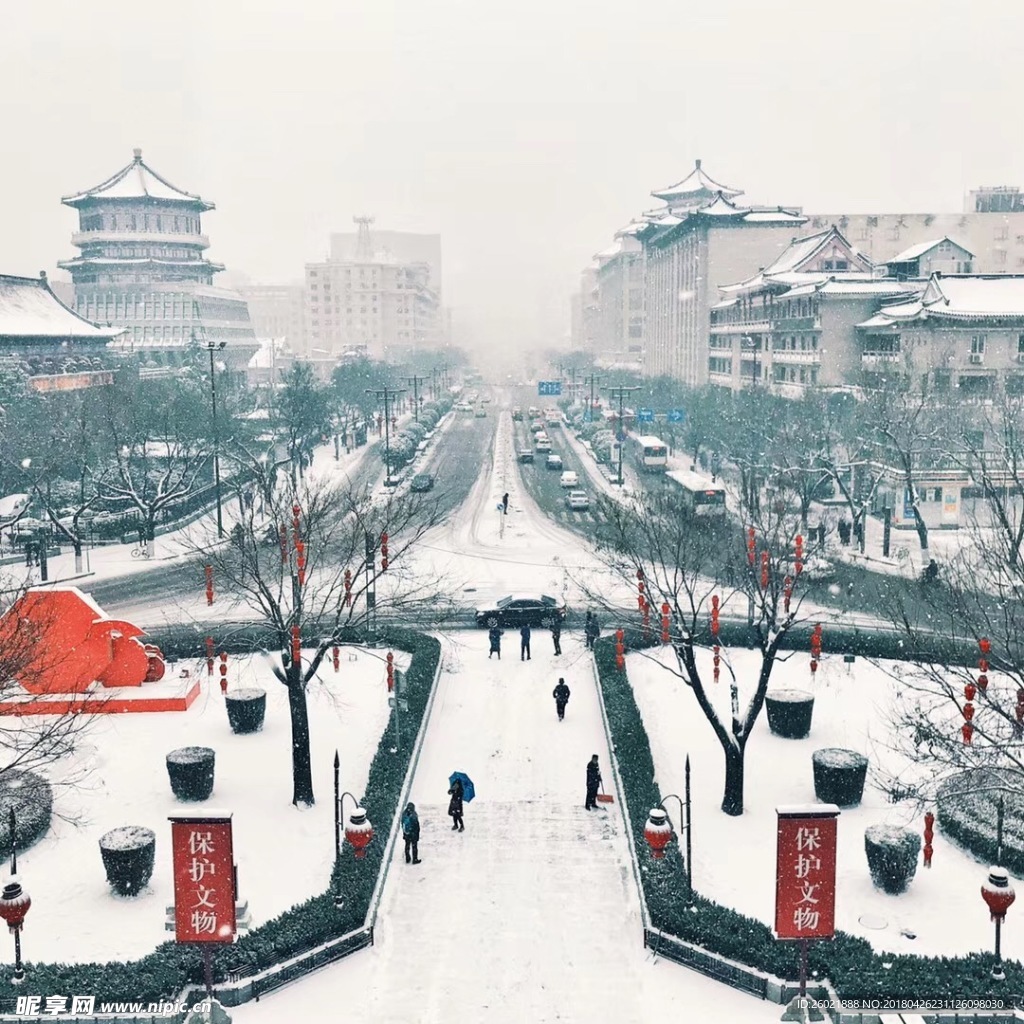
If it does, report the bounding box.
[305,217,444,364]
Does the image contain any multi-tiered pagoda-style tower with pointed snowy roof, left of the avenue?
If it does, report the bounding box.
[57,150,258,369]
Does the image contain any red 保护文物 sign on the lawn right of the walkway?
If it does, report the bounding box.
[775,804,839,939]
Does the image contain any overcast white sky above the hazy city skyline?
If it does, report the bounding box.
[0,0,1024,356]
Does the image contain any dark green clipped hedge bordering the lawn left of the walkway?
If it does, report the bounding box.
[0,629,440,1013]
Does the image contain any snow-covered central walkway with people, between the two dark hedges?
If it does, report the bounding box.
[231,632,780,1024]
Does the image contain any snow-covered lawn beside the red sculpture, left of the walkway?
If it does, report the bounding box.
[17,647,409,963]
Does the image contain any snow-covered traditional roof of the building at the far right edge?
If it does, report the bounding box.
[857,273,1024,328]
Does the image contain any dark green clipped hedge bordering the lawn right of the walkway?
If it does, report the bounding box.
[595,636,1024,1000]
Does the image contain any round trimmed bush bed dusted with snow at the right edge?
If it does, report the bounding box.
[936,768,1024,876]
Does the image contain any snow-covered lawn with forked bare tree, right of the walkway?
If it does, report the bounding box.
[627,649,1024,958]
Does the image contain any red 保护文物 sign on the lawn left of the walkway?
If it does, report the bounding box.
[170,814,238,942]
